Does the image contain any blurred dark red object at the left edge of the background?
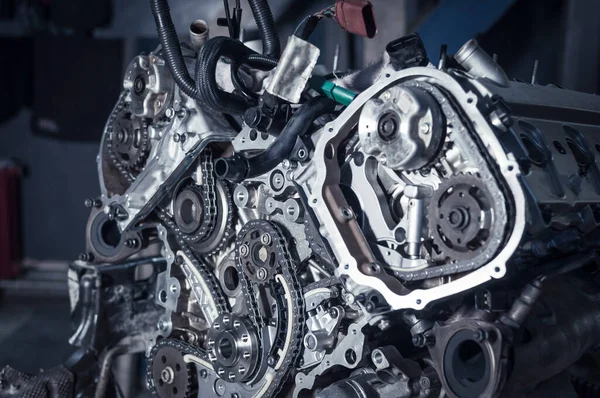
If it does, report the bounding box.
[0,164,21,279]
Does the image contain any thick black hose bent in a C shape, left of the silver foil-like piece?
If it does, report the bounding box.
[196,36,256,115]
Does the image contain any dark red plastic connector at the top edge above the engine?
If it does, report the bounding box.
[335,0,377,39]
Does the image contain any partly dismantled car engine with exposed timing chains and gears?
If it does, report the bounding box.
[59,0,600,398]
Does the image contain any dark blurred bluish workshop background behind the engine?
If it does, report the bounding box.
[0,0,600,394]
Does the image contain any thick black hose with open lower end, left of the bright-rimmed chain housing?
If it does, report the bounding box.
[215,97,335,182]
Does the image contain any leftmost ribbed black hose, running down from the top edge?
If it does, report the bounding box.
[150,0,200,100]
